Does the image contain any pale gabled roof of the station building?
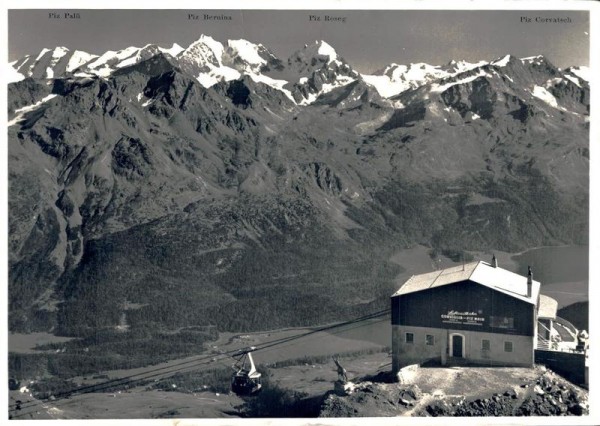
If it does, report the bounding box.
[392,261,540,305]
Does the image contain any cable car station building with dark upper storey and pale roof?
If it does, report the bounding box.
[392,257,557,373]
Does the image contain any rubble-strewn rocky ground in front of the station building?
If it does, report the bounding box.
[320,367,589,417]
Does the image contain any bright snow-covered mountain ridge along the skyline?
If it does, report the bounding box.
[7,35,590,105]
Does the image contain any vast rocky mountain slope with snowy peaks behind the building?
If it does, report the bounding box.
[8,36,589,336]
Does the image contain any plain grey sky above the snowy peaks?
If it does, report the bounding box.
[8,9,590,72]
